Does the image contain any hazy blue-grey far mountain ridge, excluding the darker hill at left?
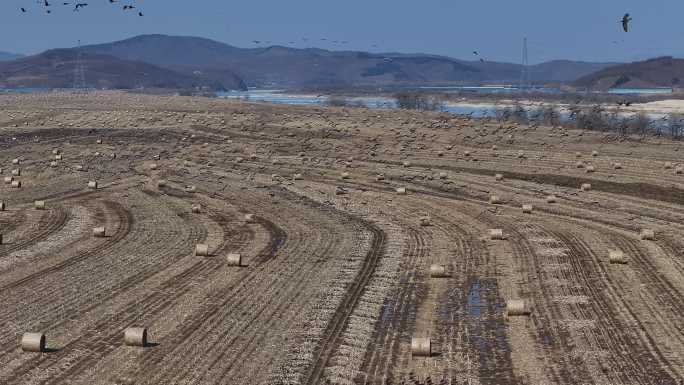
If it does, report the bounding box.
[79,35,613,87]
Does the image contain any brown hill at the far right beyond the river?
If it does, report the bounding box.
[574,56,684,91]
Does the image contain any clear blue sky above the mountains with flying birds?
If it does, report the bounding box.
[0,0,684,63]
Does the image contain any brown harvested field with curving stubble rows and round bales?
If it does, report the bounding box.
[0,92,684,385]
